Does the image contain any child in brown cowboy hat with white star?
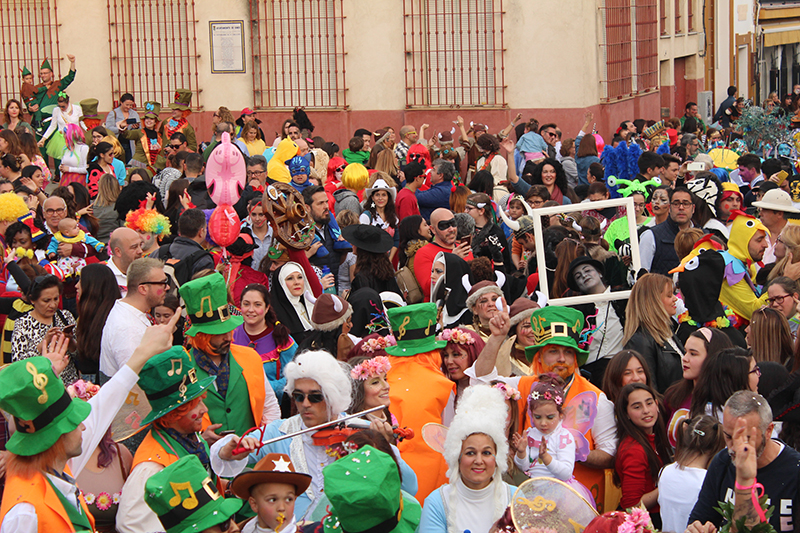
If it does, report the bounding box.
[232,453,311,533]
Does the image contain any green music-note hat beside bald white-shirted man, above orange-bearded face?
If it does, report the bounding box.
[180,272,244,337]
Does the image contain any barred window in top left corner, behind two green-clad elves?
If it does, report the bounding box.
[0,0,61,107]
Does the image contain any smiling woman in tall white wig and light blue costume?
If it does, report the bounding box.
[419,385,515,533]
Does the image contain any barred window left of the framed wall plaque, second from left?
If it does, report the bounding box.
[107,0,201,109]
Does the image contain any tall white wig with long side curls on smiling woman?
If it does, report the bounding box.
[444,385,508,532]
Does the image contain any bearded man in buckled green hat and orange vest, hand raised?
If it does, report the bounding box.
[467,302,617,505]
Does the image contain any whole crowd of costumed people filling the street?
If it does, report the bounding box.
[0,56,800,533]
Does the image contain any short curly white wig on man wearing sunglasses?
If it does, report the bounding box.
[284,350,354,420]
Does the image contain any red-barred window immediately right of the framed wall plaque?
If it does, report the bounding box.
[250,0,347,108]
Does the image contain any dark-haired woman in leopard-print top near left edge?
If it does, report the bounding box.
[11,274,78,385]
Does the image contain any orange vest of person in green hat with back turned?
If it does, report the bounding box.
[387,350,455,501]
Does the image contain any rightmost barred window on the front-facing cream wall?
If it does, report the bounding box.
[403,0,506,108]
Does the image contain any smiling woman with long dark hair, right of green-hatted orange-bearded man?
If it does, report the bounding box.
[233,283,297,412]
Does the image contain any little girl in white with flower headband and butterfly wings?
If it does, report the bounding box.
[511,374,594,503]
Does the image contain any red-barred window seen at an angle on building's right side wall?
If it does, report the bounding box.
[600,0,659,102]
